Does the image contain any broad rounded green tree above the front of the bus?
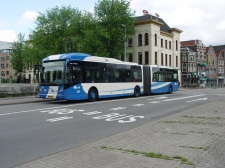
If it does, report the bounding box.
[32,6,81,58]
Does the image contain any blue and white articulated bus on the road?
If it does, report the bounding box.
[34,53,179,101]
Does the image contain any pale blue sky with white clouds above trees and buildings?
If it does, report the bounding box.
[0,0,225,46]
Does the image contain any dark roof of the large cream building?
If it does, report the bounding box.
[136,14,182,33]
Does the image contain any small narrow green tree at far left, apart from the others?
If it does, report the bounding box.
[10,33,25,81]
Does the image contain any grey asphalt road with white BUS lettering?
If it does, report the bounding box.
[0,88,225,168]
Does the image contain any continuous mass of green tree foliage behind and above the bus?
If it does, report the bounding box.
[12,0,135,68]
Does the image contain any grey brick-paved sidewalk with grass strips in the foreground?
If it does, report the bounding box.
[14,98,225,168]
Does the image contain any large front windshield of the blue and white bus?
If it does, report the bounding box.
[40,60,65,86]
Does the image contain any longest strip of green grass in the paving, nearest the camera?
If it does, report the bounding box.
[101,146,193,165]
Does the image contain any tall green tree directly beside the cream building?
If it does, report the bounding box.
[90,0,135,58]
